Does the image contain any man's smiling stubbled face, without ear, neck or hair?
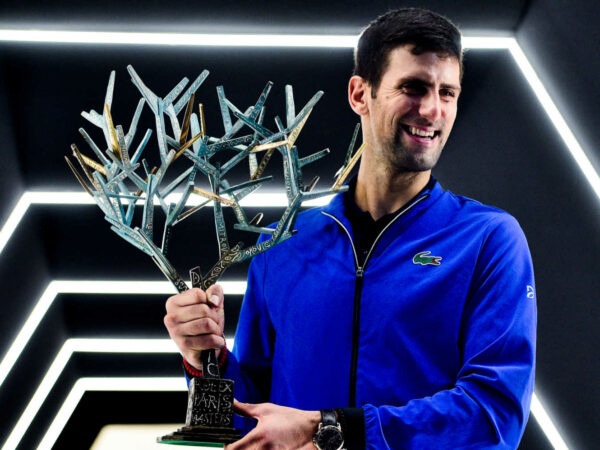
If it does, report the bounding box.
[363,45,460,172]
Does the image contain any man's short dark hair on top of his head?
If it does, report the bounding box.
[354,8,463,92]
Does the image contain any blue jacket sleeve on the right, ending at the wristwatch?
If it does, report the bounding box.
[363,217,537,450]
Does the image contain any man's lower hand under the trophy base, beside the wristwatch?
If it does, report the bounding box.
[226,400,321,450]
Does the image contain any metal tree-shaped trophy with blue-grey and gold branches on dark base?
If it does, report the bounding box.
[65,66,362,444]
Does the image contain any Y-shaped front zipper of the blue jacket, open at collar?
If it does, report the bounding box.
[323,194,429,408]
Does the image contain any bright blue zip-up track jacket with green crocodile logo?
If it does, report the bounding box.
[224,178,536,450]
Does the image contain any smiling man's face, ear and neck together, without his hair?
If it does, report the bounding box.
[348,44,461,220]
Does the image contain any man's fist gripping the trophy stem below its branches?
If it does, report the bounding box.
[164,284,225,370]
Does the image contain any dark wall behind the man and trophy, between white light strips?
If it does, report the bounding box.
[0,0,600,449]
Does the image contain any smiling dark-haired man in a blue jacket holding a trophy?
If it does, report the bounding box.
[165,9,536,450]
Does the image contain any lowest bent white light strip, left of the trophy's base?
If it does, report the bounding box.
[37,377,187,450]
